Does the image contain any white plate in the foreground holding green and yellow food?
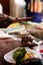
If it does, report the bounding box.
[4,47,41,64]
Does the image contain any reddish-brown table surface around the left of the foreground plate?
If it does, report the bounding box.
[0,38,43,65]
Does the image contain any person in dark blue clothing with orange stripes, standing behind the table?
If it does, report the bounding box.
[25,0,43,23]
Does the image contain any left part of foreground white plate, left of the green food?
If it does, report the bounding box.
[4,48,18,63]
